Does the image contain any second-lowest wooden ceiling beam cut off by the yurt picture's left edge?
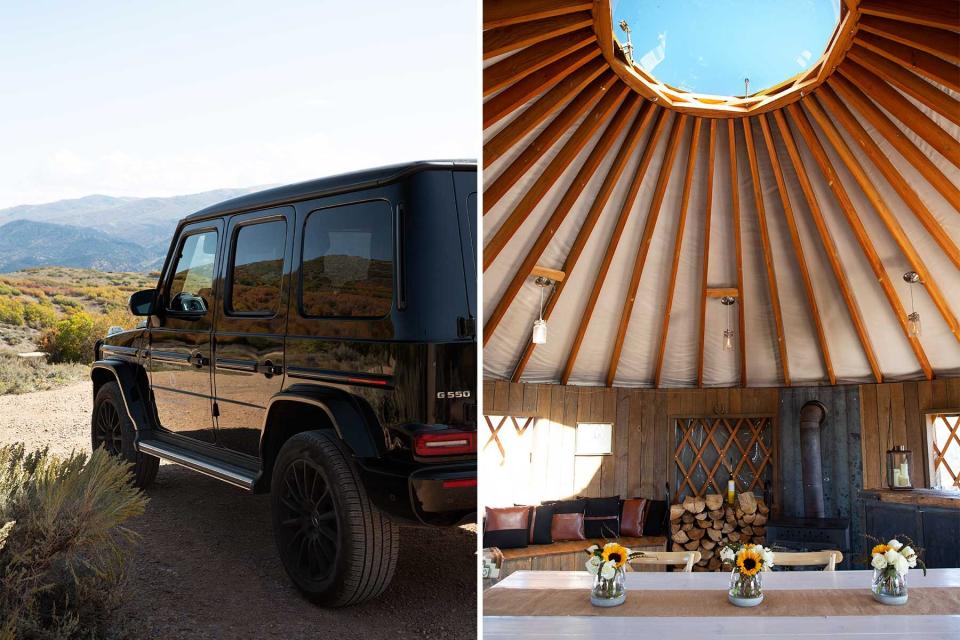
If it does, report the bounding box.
[483,82,631,271]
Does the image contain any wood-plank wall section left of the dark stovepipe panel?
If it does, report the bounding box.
[480,381,779,503]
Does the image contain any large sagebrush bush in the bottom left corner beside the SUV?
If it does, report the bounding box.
[0,444,147,640]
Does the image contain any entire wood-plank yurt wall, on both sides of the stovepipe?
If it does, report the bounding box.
[480,378,960,510]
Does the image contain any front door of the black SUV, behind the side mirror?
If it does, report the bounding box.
[149,220,223,442]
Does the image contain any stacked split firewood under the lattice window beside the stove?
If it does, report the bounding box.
[670,493,770,571]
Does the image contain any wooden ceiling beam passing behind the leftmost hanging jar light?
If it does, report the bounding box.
[512,102,662,382]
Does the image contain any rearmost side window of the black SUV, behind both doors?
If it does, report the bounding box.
[300,200,393,318]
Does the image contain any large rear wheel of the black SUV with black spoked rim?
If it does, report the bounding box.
[270,431,400,607]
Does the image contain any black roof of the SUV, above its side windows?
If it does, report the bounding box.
[182,160,477,222]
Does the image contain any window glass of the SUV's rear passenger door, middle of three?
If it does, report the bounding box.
[227,220,287,315]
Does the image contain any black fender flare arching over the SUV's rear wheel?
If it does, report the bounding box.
[260,385,384,460]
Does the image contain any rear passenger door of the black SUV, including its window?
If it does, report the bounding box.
[213,207,294,456]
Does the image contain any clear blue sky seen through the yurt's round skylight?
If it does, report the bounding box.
[613,0,840,96]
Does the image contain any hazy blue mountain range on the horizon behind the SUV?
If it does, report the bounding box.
[0,187,264,273]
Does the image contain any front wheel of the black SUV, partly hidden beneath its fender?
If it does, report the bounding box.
[90,382,160,489]
